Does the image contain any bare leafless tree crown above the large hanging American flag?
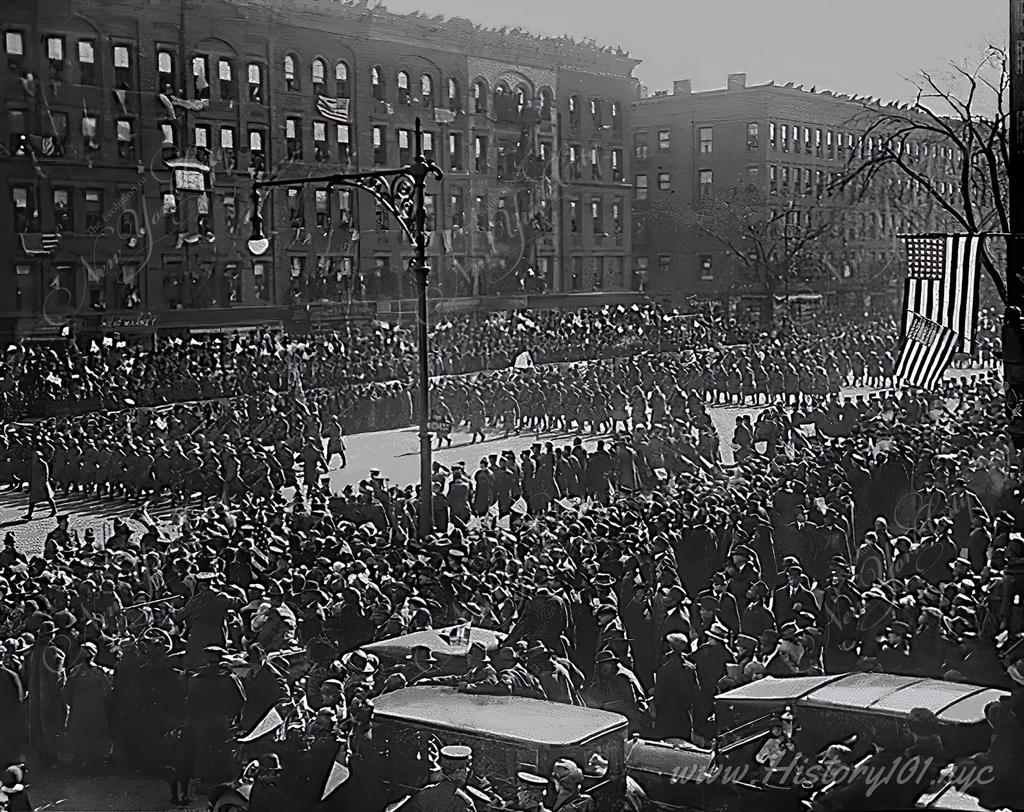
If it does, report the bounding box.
[833,45,1010,303]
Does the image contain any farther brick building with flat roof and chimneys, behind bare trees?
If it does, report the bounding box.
[632,74,955,310]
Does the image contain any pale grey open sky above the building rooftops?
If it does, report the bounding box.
[385,0,1009,100]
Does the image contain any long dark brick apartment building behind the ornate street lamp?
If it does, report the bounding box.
[0,0,637,335]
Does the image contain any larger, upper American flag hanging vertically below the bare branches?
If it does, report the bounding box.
[903,234,982,353]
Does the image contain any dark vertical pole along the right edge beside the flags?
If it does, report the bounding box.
[1002,0,1024,451]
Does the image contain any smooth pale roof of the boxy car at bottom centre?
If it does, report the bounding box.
[374,686,628,746]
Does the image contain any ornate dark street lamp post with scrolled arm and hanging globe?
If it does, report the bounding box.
[249,119,443,537]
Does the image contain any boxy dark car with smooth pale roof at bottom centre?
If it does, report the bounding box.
[374,686,628,812]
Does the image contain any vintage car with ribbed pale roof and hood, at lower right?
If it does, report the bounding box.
[627,674,1007,812]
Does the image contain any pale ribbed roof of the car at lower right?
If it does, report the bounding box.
[718,674,1008,724]
